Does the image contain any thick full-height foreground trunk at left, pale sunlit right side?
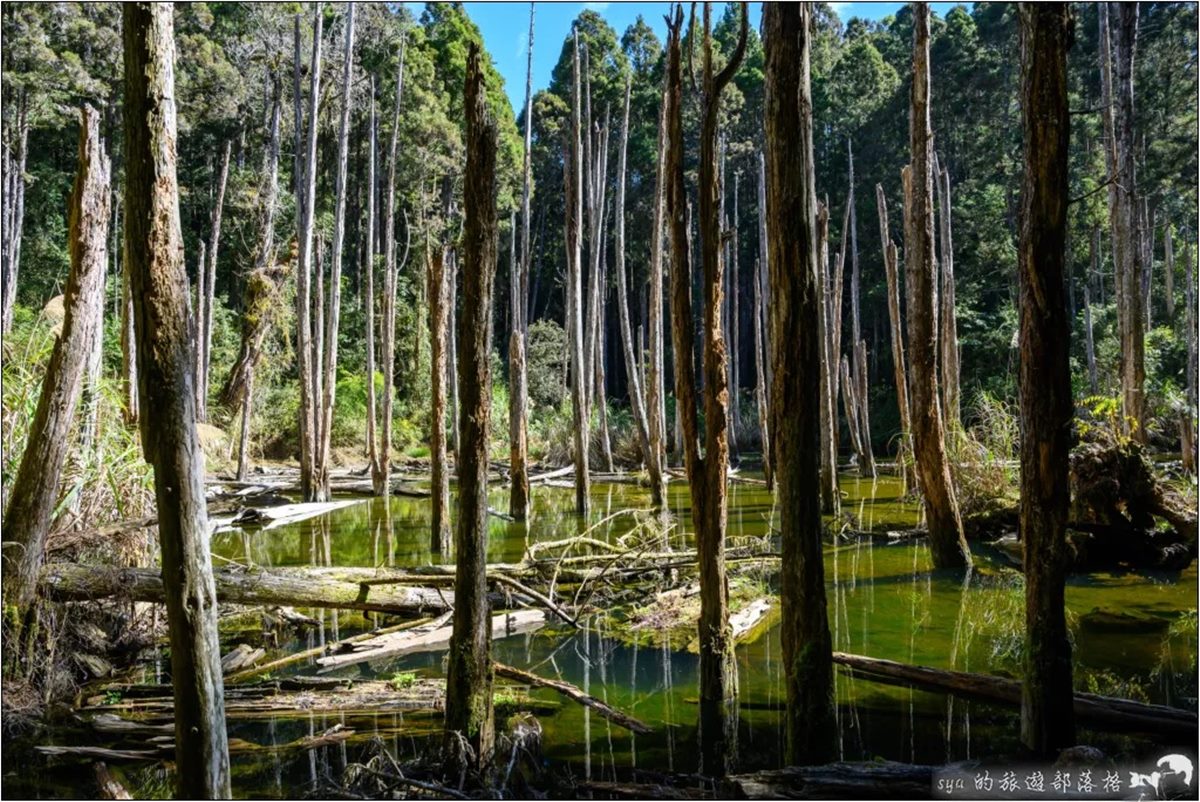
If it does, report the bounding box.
[122,4,230,798]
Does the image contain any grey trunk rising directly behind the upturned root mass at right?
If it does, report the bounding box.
[1099,2,1146,442]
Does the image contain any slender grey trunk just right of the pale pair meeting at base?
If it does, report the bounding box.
[371,35,412,496]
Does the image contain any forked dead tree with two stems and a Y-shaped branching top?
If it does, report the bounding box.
[667,5,749,776]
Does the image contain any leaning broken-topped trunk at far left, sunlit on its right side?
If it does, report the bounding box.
[4,106,110,615]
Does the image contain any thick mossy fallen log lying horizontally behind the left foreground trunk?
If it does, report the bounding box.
[40,563,454,616]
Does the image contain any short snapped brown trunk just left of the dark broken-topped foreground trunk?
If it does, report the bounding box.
[425,241,450,553]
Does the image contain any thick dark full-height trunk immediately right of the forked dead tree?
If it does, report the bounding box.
[762,2,836,764]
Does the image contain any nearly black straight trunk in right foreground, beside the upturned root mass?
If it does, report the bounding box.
[1018,4,1075,755]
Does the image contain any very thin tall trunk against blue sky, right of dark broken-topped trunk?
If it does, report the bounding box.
[509,2,534,521]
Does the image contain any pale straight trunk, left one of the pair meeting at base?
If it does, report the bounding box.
[293,8,324,501]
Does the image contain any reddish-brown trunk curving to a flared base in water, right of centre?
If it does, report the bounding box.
[905,2,971,568]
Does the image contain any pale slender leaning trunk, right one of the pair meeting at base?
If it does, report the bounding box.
[316,2,354,499]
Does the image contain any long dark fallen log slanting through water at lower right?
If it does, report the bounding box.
[833,652,1198,738]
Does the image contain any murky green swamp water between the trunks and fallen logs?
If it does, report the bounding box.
[4,477,1196,797]
